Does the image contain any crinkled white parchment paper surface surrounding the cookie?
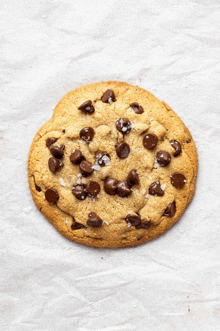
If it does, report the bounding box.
[0,0,220,331]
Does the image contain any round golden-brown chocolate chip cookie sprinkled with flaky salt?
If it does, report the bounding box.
[28,82,198,247]
